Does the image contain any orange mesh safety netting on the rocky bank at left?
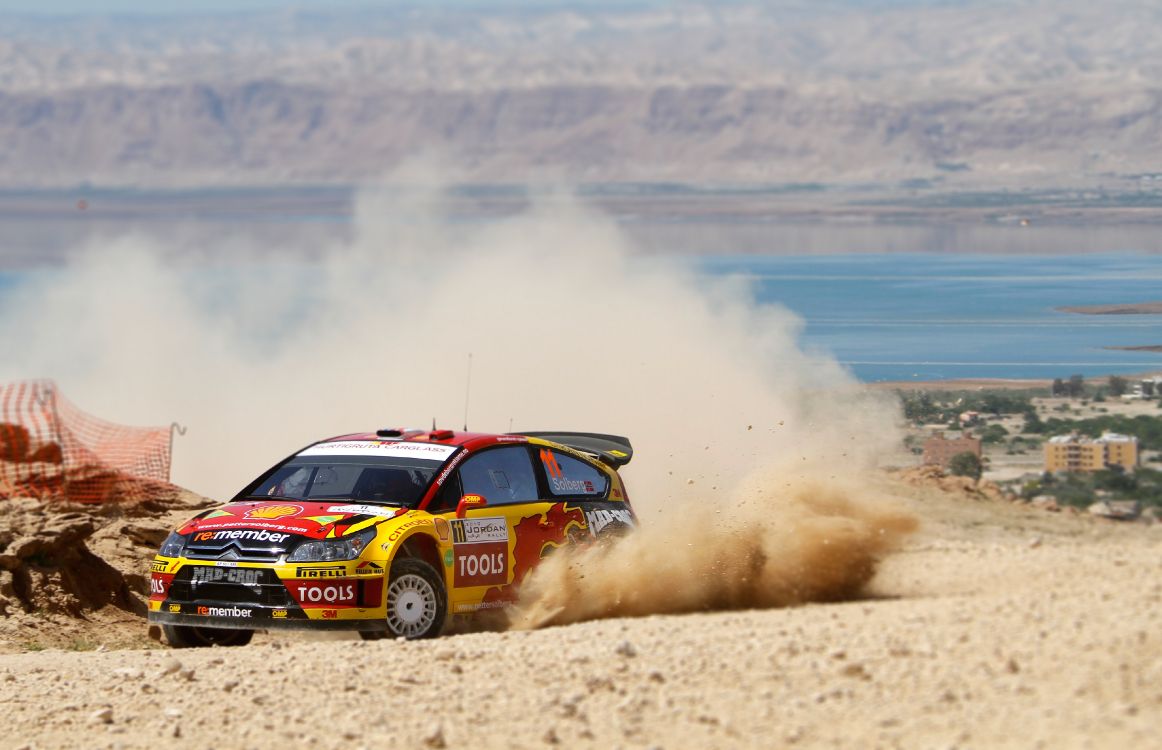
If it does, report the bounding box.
[0,380,171,502]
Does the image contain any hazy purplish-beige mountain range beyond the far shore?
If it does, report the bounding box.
[0,1,1162,187]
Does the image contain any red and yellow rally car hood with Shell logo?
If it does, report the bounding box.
[178,500,408,540]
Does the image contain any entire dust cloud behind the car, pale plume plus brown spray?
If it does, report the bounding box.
[0,180,903,619]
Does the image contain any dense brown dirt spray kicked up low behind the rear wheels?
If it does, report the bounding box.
[512,470,917,629]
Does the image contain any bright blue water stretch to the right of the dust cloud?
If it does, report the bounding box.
[700,253,1162,381]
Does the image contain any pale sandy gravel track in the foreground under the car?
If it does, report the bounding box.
[0,479,1162,748]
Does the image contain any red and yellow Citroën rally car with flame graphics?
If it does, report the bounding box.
[149,429,636,648]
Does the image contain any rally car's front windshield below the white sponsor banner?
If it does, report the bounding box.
[249,456,443,507]
